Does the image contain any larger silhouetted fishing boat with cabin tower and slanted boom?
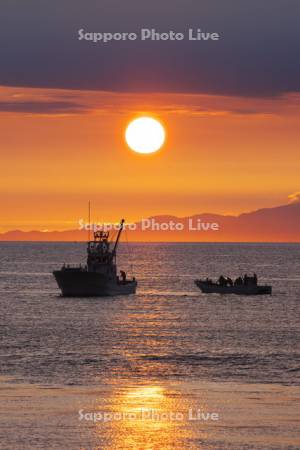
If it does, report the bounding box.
[53,219,137,297]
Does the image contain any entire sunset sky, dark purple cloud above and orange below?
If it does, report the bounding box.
[0,0,300,231]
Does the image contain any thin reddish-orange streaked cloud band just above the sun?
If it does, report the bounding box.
[0,86,300,118]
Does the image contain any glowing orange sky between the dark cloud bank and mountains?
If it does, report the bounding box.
[0,87,300,231]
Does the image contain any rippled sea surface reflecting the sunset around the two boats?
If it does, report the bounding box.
[0,242,300,450]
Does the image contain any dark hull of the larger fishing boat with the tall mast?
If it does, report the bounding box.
[53,270,137,297]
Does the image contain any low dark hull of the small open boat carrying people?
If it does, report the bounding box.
[195,280,272,295]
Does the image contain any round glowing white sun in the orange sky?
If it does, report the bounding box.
[125,117,166,153]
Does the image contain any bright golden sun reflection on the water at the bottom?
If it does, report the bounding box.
[94,385,206,450]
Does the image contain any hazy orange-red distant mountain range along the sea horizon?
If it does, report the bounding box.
[0,201,300,242]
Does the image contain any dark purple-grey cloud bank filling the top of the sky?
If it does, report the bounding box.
[0,0,300,97]
